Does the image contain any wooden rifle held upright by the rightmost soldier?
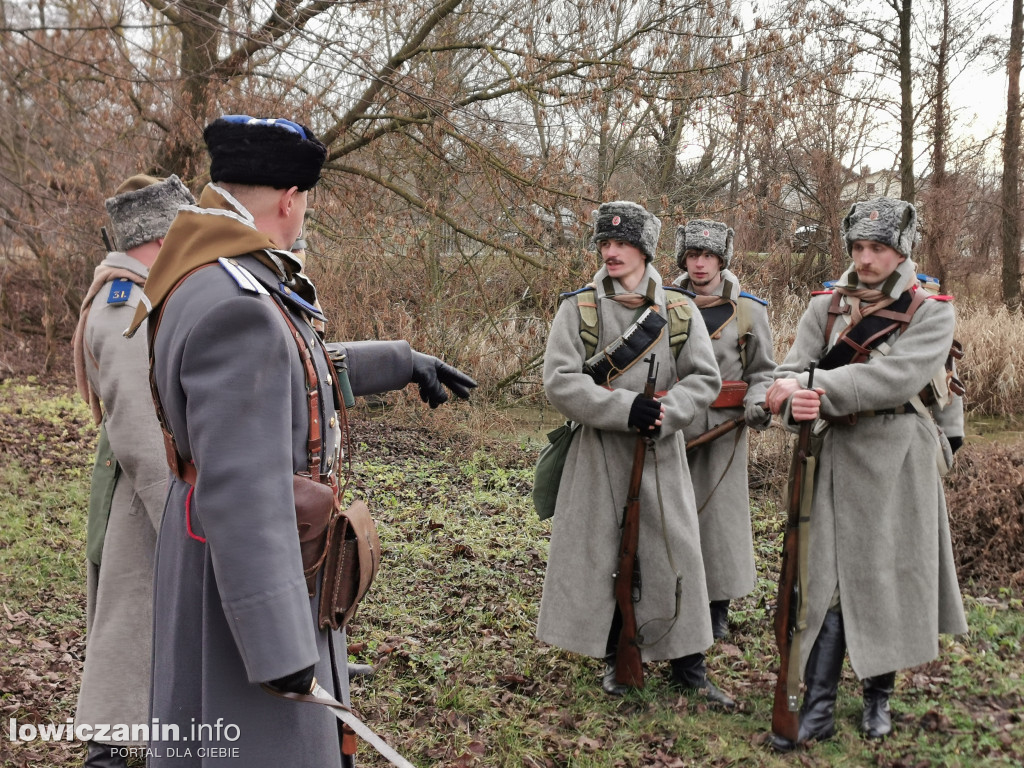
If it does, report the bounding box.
[771,362,815,744]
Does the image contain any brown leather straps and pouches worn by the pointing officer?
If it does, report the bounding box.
[147,264,381,630]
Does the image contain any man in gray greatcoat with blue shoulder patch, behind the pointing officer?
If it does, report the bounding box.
[73,175,196,768]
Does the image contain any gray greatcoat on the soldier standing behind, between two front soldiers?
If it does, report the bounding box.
[676,270,775,600]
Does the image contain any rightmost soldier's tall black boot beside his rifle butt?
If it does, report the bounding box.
[771,610,846,752]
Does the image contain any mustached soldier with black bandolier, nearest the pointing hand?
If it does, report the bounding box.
[537,201,735,709]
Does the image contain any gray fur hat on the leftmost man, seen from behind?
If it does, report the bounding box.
[105,174,196,251]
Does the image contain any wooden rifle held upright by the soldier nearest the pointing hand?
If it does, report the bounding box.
[615,353,657,688]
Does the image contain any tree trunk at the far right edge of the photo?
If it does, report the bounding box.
[1001,0,1024,309]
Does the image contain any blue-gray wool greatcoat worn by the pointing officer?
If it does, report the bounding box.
[148,254,412,768]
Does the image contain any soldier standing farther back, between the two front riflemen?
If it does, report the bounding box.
[674,219,775,639]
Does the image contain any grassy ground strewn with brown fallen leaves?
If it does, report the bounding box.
[0,380,1024,768]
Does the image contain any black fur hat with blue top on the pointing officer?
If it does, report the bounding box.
[203,115,327,191]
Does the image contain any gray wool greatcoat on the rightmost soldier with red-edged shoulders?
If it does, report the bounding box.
[778,261,968,679]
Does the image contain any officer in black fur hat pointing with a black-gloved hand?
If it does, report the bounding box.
[130,115,475,768]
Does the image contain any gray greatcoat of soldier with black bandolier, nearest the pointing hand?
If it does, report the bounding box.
[537,264,720,662]
